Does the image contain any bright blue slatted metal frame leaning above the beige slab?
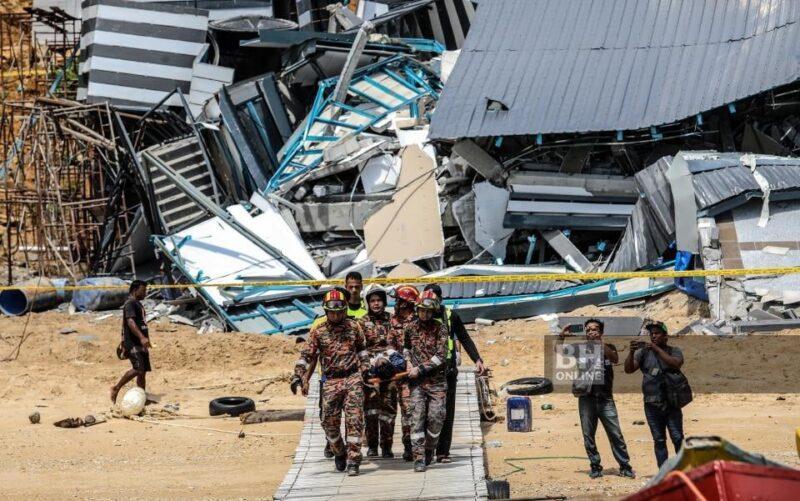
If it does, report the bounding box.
[264,55,442,193]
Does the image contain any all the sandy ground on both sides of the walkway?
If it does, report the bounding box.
[0,294,800,499]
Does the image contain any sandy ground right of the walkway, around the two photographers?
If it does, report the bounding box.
[473,293,800,497]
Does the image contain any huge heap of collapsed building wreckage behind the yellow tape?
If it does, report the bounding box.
[0,0,800,334]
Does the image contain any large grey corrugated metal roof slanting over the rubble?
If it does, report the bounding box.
[430,0,800,139]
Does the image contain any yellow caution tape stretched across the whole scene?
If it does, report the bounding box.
[0,266,800,292]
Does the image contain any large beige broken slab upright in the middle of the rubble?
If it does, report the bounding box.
[364,146,444,267]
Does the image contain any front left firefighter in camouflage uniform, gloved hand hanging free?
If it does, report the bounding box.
[291,289,369,476]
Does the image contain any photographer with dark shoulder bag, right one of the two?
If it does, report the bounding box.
[625,322,683,468]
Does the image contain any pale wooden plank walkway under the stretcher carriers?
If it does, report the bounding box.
[275,371,487,501]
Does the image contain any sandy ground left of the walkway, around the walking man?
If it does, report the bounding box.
[0,313,303,499]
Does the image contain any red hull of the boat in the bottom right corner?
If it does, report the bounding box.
[624,461,800,501]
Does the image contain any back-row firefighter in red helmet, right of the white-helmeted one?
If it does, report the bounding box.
[389,285,419,461]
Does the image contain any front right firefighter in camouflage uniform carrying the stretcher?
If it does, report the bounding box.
[404,291,448,472]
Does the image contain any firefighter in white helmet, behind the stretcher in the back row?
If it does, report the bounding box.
[359,285,397,458]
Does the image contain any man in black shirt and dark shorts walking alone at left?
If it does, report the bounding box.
[111,280,151,403]
